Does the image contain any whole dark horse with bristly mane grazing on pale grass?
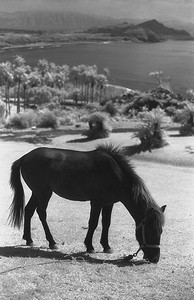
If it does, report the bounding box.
[9,145,165,263]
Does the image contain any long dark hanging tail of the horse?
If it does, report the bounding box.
[9,159,25,228]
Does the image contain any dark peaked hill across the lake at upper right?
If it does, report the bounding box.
[88,20,194,42]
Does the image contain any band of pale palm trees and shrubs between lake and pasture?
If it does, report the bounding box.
[0,56,194,141]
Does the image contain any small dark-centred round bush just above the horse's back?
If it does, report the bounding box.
[83,112,111,140]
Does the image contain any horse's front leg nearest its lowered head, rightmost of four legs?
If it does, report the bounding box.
[100,204,113,253]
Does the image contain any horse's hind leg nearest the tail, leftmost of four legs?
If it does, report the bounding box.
[23,194,37,246]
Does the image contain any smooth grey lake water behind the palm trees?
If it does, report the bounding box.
[0,41,194,93]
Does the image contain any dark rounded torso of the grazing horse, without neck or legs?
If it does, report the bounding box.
[18,147,122,202]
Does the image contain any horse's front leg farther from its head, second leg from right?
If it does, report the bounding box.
[84,201,101,253]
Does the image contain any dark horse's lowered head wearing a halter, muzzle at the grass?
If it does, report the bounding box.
[136,206,166,263]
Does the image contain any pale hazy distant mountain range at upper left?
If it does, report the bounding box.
[0,11,118,32]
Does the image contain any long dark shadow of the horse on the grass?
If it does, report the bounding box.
[0,246,148,274]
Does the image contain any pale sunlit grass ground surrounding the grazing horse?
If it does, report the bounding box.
[0,132,194,300]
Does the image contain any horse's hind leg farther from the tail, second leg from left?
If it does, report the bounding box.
[37,192,57,249]
